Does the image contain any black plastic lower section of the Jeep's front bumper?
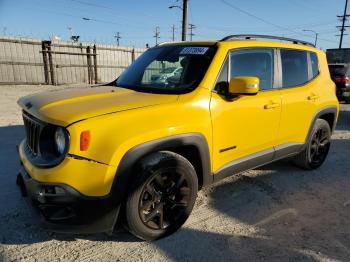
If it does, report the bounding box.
[17,166,120,234]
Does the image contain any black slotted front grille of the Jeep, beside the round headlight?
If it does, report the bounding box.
[23,112,43,155]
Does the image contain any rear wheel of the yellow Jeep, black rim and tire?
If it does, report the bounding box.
[293,119,332,170]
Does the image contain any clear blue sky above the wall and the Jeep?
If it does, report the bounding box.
[0,0,350,49]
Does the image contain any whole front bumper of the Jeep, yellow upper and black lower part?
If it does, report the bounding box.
[17,142,121,234]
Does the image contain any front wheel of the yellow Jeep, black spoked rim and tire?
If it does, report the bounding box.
[125,151,198,241]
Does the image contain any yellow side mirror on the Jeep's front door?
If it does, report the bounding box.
[228,76,260,95]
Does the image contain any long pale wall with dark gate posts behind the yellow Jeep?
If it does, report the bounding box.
[0,36,145,85]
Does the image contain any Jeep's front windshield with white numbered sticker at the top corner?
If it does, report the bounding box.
[115,45,217,94]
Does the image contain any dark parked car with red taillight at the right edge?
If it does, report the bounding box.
[328,63,350,104]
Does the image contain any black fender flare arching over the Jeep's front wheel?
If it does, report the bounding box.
[110,133,213,227]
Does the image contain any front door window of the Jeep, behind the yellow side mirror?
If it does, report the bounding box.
[230,48,274,90]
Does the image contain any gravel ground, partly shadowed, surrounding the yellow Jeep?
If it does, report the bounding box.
[0,86,350,261]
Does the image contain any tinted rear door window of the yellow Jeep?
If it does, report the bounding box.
[281,49,308,87]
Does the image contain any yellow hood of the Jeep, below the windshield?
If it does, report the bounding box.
[18,86,178,126]
